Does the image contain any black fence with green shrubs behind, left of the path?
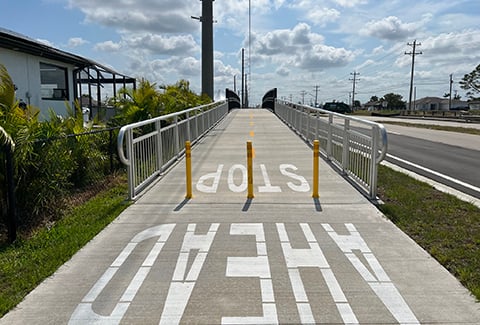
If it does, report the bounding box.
[0,128,122,242]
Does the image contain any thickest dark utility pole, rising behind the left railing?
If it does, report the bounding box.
[191,0,215,100]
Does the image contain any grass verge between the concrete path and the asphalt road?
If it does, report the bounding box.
[378,166,480,300]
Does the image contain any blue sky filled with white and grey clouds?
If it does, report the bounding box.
[0,0,480,104]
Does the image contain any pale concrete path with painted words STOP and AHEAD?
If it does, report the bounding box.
[0,110,480,324]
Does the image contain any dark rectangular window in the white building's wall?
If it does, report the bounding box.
[40,63,68,100]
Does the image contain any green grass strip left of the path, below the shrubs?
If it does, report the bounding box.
[0,179,128,317]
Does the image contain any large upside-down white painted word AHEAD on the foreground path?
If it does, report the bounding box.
[70,223,419,324]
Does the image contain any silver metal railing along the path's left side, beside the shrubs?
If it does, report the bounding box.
[117,101,228,200]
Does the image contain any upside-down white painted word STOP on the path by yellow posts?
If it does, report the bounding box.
[196,164,310,193]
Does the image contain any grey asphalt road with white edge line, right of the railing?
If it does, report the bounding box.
[364,118,480,198]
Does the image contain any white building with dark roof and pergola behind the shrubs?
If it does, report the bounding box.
[0,28,136,117]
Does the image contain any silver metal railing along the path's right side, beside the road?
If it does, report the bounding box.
[275,100,387,199]
